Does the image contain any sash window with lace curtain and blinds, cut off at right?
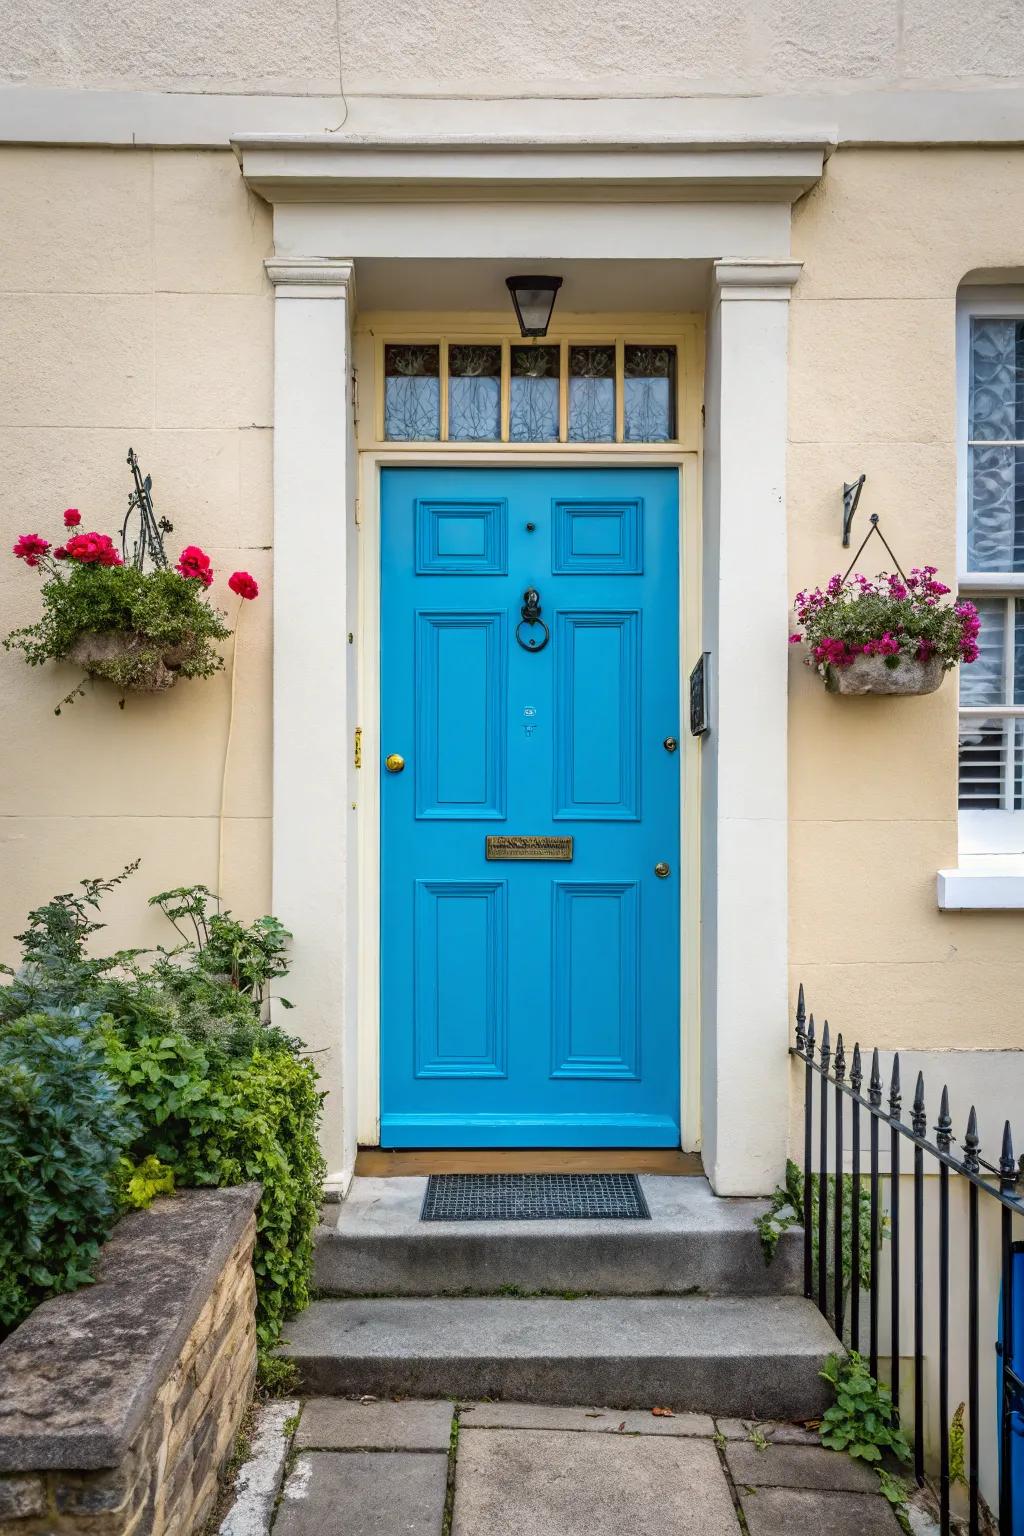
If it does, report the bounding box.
[960,298,1024,852]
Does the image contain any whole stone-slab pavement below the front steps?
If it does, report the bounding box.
[273,1398,900,1536]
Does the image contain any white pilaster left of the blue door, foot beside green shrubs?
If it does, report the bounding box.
[266,257,356,1184]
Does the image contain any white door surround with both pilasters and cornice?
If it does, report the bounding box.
[250,135,827,1195]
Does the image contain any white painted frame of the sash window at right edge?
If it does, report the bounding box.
[956,287,1024,857]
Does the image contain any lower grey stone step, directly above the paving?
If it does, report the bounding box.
[281,1296,837,1419]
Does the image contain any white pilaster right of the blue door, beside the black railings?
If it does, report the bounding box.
[702,260,800,1195]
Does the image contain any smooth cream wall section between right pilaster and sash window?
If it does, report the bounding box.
[789,149,1024,1050]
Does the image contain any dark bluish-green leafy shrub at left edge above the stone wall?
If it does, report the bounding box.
[0,1011,140,1332]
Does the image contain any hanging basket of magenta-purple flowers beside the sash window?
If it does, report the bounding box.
[789,565,981,696]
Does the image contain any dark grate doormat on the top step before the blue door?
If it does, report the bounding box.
[419,1174,651,1221]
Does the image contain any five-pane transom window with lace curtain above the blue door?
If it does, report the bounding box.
[382,336,679,442]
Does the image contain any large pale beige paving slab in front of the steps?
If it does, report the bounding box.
[451,1428,739,1536]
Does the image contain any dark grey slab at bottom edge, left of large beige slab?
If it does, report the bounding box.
[273,1450,445,1536]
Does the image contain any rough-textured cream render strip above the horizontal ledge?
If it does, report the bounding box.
[0,0,1024,97]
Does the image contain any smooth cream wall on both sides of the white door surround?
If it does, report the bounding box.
[0,138,1024,1069]
